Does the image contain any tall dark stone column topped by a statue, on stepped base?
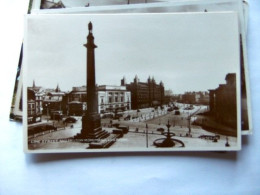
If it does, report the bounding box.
[78,22,109,142]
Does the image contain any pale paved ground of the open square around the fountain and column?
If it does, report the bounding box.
[26,103,238,151]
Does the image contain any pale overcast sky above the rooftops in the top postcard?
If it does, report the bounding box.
[24,13,239,93]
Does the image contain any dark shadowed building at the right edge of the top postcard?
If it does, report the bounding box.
[209,73,237,128]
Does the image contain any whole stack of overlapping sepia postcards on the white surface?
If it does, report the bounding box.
[10,0,252,153]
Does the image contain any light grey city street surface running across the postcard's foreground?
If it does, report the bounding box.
[26,104,236,150]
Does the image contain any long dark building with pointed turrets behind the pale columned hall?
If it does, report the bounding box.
[121,76,164,109]
